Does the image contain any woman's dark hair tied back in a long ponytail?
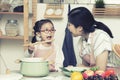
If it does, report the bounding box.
[68,7,113,38]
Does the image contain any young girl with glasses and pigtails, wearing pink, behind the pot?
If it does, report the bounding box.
[28,19,64,71]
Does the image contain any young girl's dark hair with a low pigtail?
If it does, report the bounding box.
[31,19,53,43]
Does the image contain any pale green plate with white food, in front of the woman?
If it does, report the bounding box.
[61,67,89,77]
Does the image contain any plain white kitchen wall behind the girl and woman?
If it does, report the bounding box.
[0,4,120,73]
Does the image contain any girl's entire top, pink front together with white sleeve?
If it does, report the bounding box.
[32,43,64,71]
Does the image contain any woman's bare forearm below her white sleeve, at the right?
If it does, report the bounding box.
[96,51,108,70]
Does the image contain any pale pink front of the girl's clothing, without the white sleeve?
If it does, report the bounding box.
[34,44,56,62]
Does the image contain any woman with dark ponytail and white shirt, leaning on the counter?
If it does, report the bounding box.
[68,7,113,70]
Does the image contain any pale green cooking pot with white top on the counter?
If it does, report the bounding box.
[20,58,49,76]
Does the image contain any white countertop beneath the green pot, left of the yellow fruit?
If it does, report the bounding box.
[0,71,70,80]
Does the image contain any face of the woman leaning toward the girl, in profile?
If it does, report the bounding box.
[68,23,82,37]
